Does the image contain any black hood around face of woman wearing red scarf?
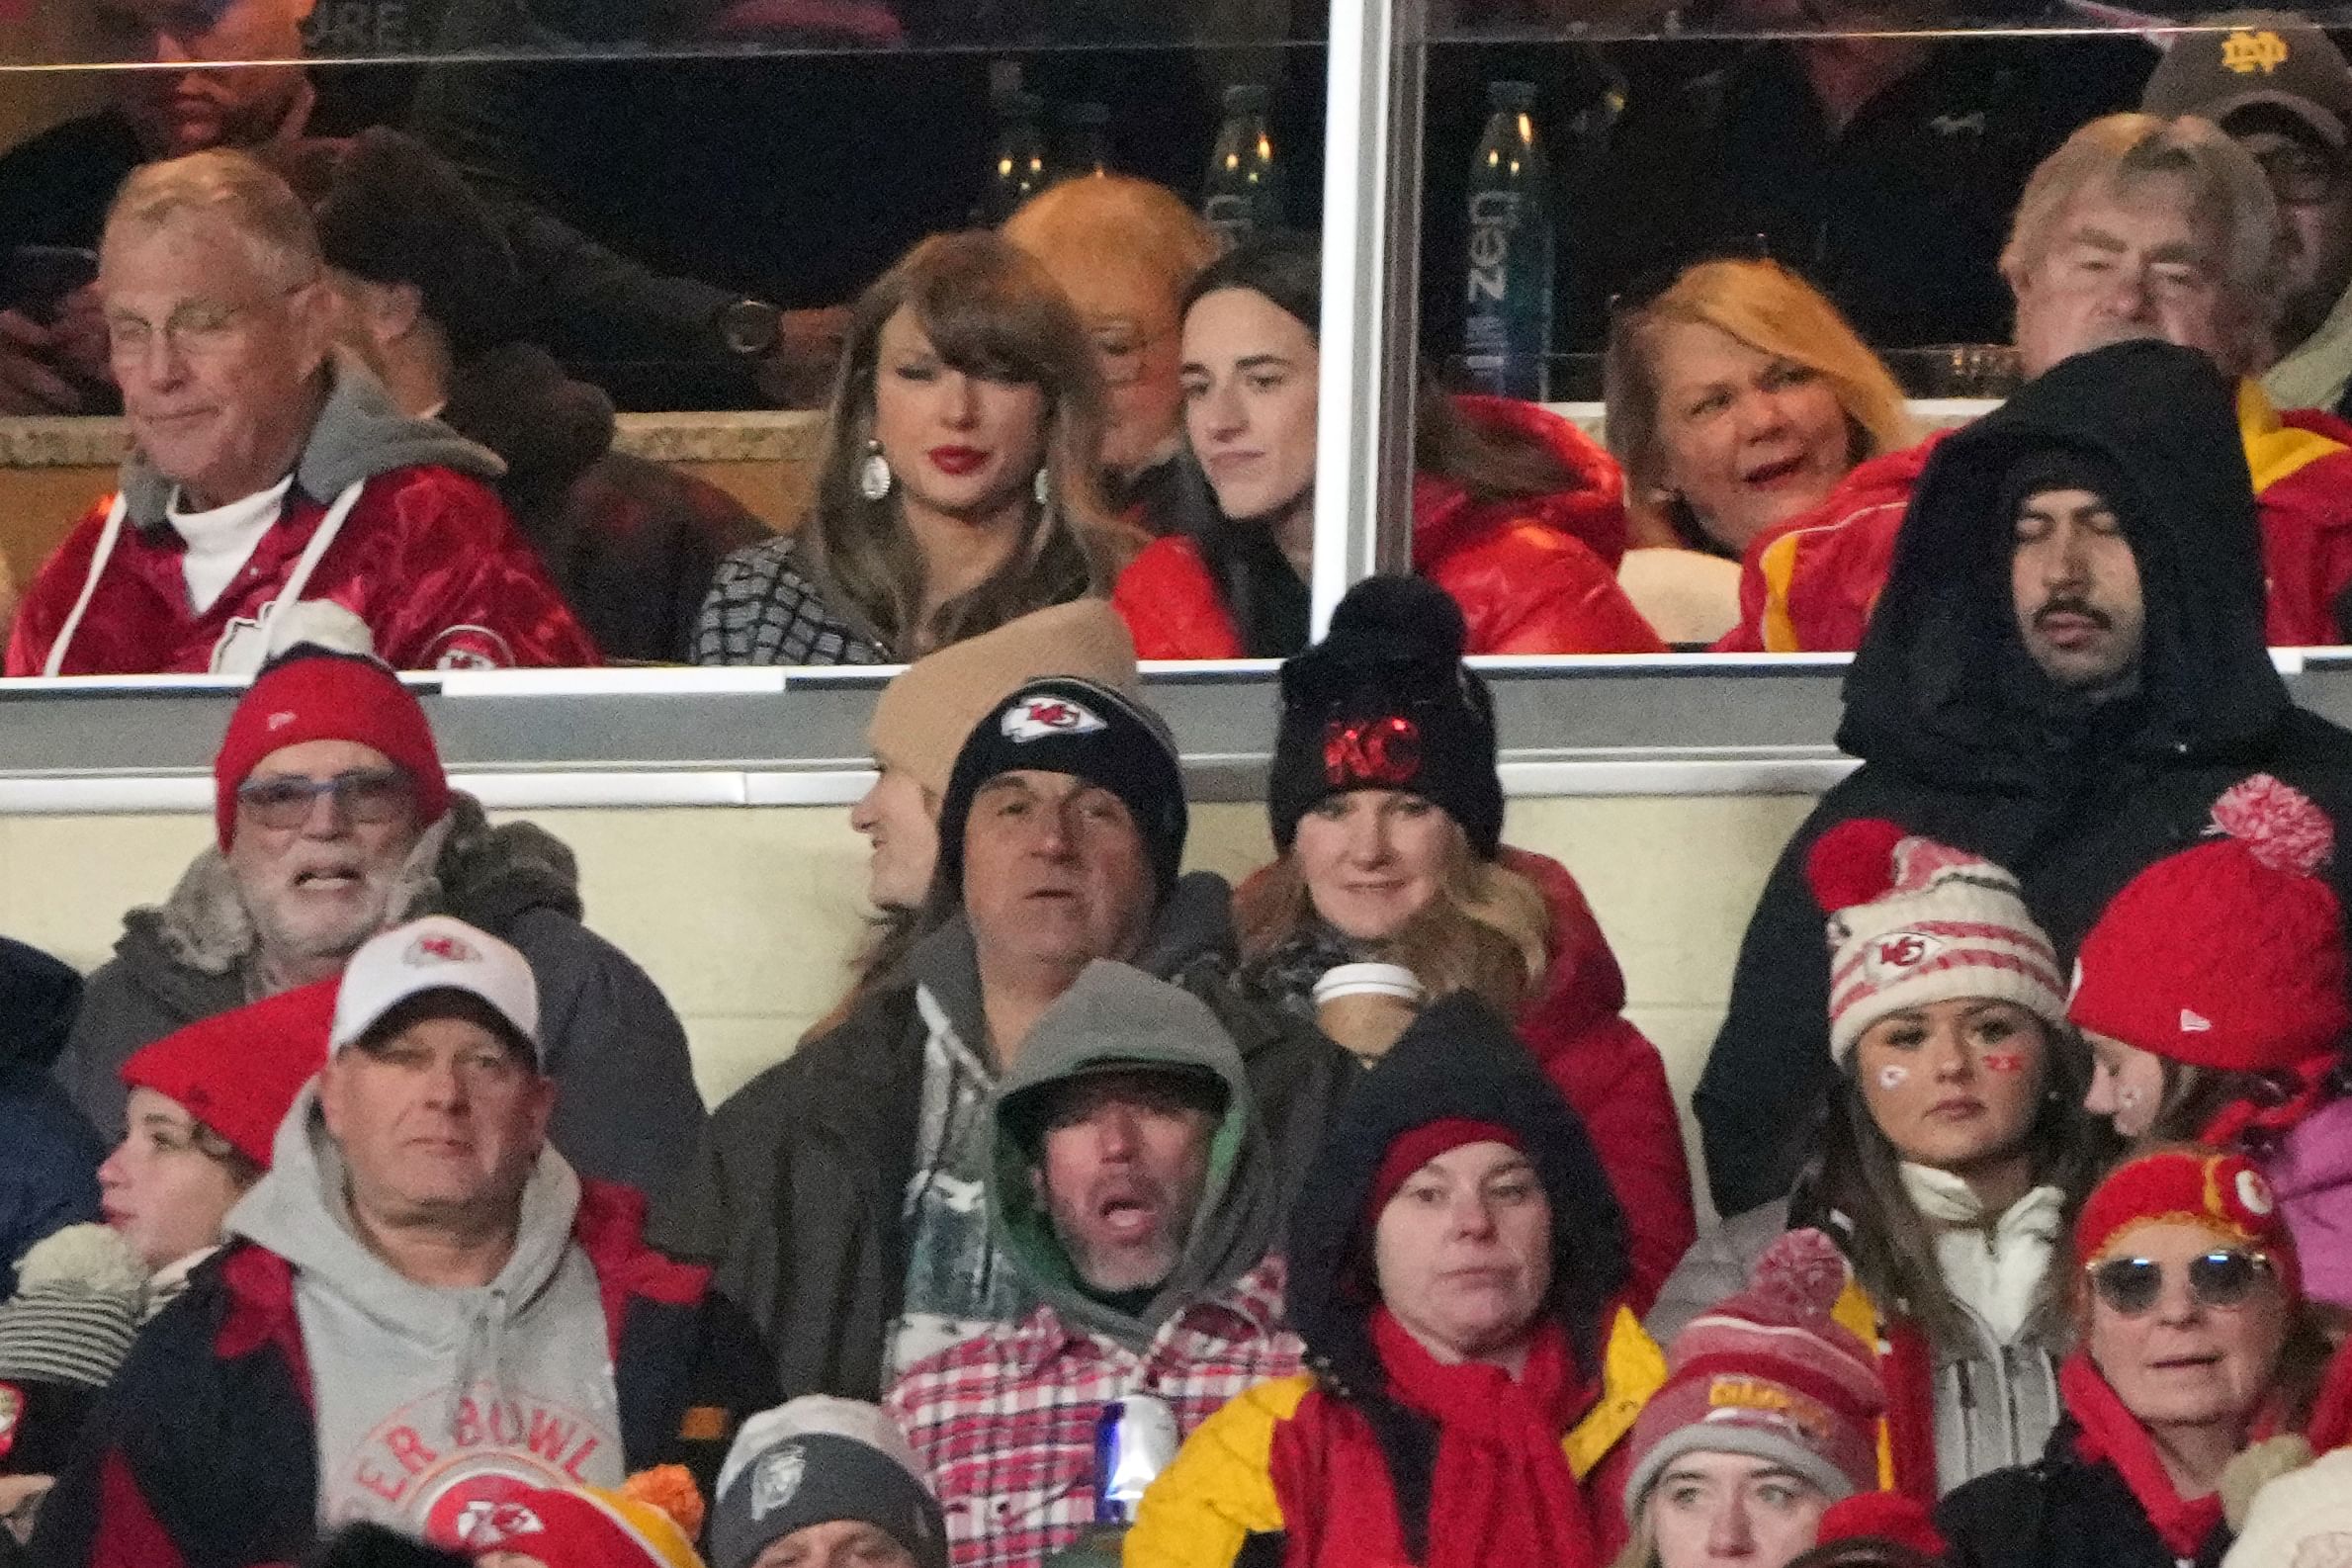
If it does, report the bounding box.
[1286,992,1630,1392]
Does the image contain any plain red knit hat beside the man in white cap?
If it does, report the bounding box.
[123,981,336,1171]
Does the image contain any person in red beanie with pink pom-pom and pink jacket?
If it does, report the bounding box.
[2067,773,2352,1305]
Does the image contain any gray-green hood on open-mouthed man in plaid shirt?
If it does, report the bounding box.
[988,959,1282,1350]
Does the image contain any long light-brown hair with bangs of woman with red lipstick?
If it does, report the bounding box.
[795,230,1119,658]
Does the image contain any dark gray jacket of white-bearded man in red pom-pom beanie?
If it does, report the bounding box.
[54,792,703,1199]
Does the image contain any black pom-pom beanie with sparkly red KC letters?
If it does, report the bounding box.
[1265,576,1503,860]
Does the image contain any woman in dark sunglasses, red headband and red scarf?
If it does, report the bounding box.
[1938,1150,2326,1568]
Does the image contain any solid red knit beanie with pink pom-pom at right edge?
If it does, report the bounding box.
[2067,773,2352,1072]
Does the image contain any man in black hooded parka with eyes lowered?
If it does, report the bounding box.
[1696,343,2352,1213]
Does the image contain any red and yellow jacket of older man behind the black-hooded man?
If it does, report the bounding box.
[1714,381,2352,653]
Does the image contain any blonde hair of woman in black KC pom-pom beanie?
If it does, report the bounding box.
[1233,818,1552,1018]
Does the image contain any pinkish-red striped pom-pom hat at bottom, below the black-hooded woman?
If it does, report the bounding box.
[1625,1230,1886,1519]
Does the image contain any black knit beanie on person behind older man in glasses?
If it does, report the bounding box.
[315,127,522,365]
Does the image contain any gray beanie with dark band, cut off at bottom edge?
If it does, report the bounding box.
[710,1394,948,1568]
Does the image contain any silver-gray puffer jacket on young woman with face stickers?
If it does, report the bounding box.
[1642,1199,2065,1493]
